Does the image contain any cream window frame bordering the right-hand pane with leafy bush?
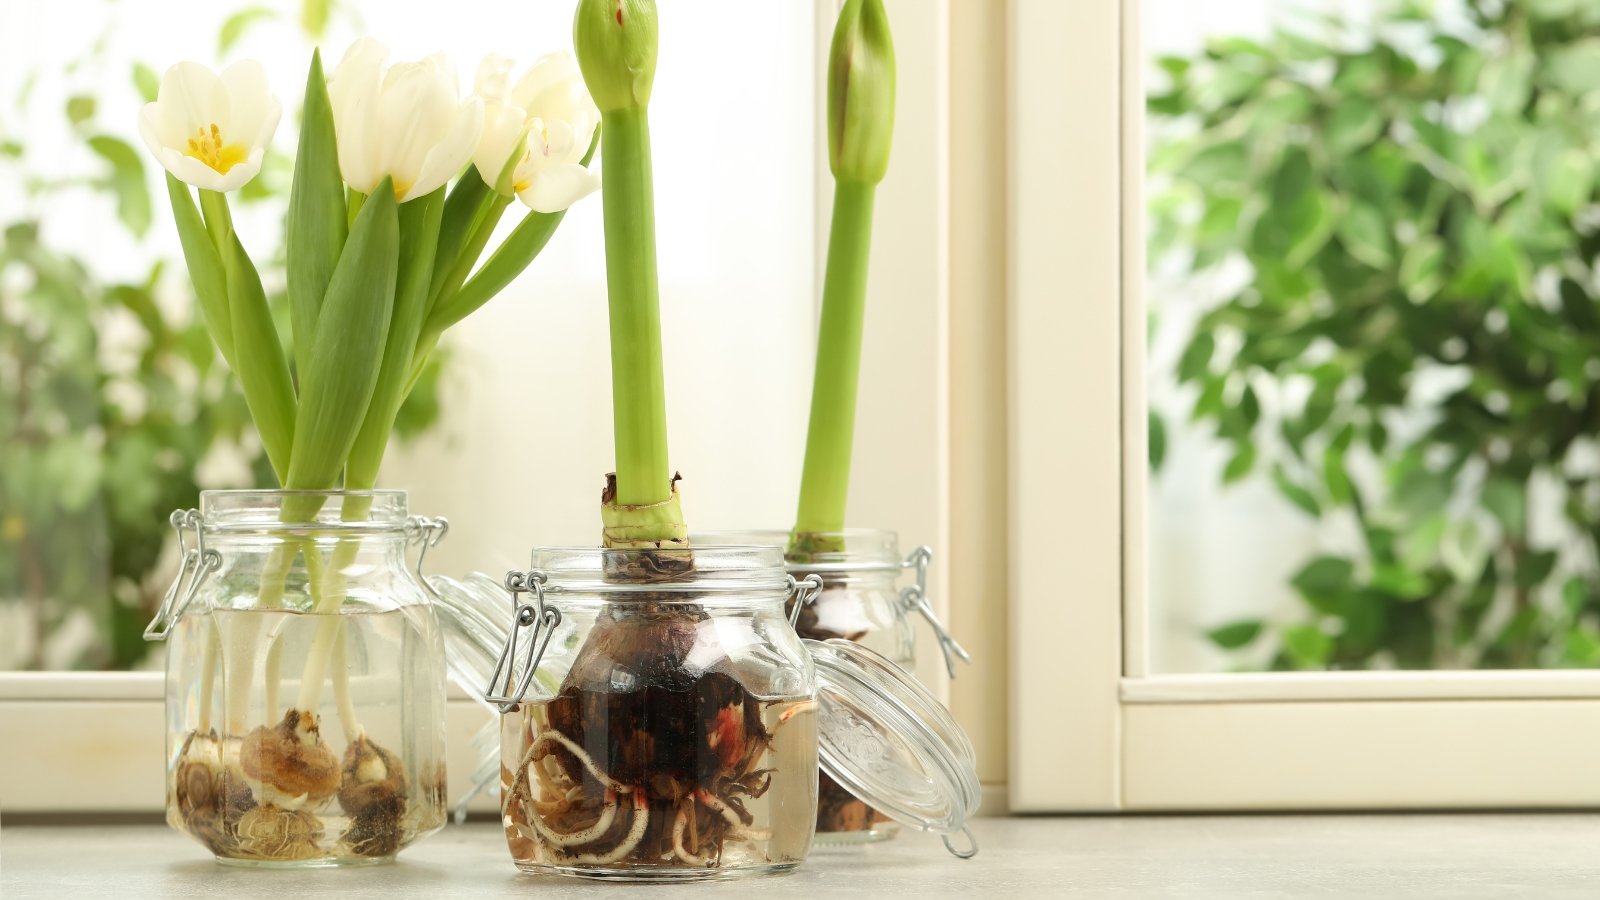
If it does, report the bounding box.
[1008,0,1600,812]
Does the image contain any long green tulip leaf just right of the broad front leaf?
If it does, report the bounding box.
[346,187,445,490]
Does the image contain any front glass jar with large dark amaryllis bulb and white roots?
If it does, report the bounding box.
[490,546,818,881]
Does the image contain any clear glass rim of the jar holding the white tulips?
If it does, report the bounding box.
[200,488,408,533]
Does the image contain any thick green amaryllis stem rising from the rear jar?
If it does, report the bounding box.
[795,181,875,533]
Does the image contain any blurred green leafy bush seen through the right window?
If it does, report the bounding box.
[1149,0,1600,669]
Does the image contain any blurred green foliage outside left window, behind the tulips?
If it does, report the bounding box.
[0,0,446,669]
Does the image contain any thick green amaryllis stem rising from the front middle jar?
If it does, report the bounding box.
[600,106,672,506]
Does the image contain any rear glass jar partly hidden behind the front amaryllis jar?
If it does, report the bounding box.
[691,528,968,844]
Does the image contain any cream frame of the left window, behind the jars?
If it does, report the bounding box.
[0,0,960,814]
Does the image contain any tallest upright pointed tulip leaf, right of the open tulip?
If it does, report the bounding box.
[285,51,347,378]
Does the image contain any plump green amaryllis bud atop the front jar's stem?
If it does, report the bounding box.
[573,0,659,112]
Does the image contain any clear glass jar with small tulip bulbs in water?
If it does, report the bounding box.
[146,490,445,866]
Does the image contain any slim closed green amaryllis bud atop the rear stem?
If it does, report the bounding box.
[832,0,894,184]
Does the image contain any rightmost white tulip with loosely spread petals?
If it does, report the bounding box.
[472,53,600,213]
